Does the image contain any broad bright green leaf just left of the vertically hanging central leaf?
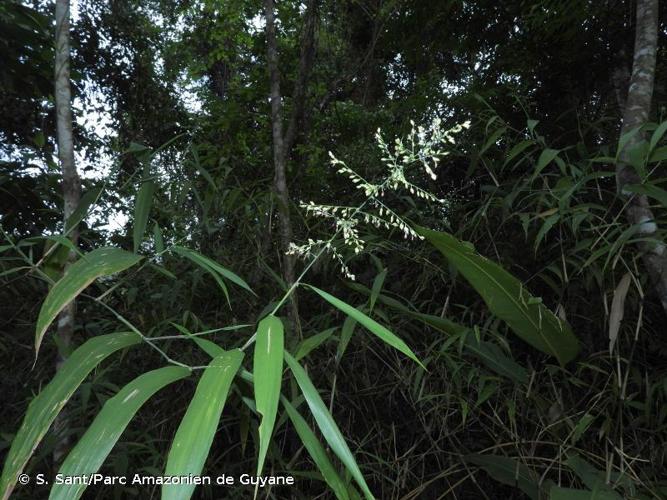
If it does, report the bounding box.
[162,349,243,500]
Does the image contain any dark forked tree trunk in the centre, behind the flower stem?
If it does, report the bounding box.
[264,0,317,333]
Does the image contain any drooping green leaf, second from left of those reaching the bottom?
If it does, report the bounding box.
[49,366,190,500]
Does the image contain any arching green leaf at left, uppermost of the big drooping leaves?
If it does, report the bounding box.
[35,247,142,354]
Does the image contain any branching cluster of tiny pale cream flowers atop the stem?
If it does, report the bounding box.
[287,119,470,280]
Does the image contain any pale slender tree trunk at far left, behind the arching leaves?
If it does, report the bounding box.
[54,0,81,463]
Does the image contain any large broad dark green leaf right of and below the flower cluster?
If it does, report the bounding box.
[417,227,579,364]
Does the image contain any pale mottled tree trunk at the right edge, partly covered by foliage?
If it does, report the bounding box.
[616,0,667,312]
